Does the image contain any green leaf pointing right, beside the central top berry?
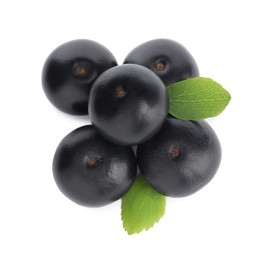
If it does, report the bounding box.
[167,77,231,120]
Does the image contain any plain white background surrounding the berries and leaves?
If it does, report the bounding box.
[0,0,266,260]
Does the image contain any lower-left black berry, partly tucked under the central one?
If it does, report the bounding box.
[53,125,137,207]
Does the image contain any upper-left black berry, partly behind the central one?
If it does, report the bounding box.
[42,40,117,115]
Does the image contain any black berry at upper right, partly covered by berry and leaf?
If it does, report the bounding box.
[124,39,199,87]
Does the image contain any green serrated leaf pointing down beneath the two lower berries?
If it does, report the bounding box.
[121,175,166,235]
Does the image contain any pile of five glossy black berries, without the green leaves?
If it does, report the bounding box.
[42,39,230,234]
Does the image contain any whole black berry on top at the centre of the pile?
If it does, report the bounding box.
[89,64,168,146]
